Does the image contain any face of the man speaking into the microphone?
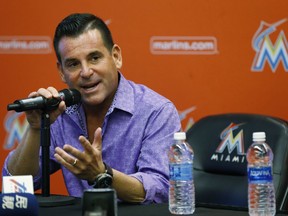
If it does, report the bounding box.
[58,29,122,106]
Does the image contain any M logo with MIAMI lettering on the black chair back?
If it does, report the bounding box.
[211,123,246,163]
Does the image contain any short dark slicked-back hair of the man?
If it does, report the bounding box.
[53,13,114,62]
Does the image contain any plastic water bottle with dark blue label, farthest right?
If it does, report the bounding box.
[246,132,276,216]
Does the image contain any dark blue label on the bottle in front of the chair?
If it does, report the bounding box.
[248,167,273,183]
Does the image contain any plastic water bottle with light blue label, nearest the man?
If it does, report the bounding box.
[168,132,195,215]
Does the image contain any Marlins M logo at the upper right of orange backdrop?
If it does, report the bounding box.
[251,19,288,72]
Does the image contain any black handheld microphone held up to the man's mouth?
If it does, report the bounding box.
[7,89,81,112]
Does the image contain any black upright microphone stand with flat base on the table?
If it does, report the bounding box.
[37,110,75,207]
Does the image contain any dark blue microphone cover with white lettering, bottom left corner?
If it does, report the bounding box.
[0,193,39,216]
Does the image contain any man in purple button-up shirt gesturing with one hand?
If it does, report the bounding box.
[3,14,181,203]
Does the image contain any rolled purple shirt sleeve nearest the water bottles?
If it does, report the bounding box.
[130,103,181,203]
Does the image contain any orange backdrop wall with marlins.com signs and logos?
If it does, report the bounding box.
[0,0,288,194]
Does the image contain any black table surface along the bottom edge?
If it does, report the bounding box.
[39,199,288,216]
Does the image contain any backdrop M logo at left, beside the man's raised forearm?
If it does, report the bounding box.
[4,112,28,150]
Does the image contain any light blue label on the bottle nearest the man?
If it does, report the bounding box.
[169,163,193,181]
